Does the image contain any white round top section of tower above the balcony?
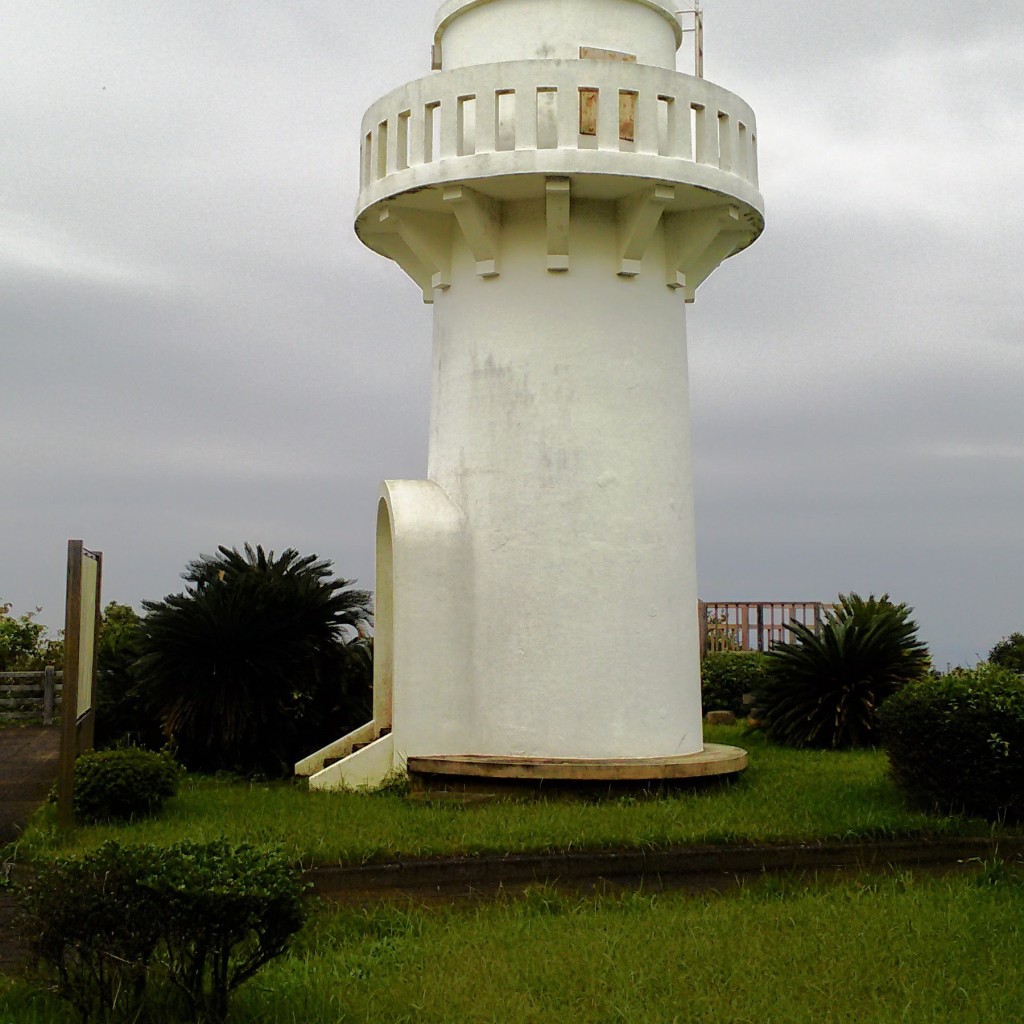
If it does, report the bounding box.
[434,0,683,71]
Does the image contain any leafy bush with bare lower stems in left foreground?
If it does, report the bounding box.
[20,841,304,1024]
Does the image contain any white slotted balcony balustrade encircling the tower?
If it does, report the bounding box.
[359,60,760,209]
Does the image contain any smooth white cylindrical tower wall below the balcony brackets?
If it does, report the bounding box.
[428,201,701,758]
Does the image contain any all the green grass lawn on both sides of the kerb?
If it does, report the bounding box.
[0,728,1024,1024]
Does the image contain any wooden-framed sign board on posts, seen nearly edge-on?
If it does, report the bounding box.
[57,541,103,828]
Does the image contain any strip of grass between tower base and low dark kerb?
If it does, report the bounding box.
[9,727,1015,865]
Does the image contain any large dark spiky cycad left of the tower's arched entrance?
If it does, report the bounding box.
[135,545,372,774]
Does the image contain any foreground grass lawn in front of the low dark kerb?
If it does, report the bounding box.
[0,867,1024,1024]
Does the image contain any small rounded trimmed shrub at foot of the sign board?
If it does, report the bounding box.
[72,746,181,822]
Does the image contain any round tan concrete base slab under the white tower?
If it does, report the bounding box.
[408,743,748,787]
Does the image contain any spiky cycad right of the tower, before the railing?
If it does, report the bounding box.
[754,594,930,750]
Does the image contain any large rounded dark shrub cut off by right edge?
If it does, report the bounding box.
[879,664,1024,820]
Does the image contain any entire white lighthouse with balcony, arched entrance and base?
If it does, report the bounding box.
[298,0,763,787]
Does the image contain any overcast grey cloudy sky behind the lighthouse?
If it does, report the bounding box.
[0,0,1024,665]
